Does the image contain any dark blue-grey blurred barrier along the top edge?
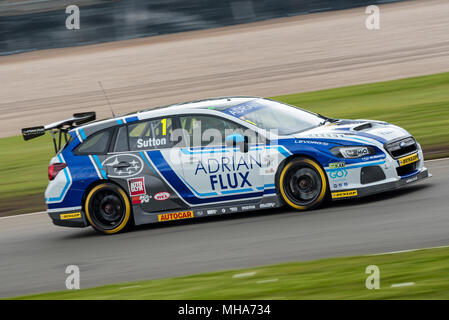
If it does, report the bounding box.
[0,0,400,55]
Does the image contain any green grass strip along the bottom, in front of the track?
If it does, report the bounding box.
[9,248,449,300]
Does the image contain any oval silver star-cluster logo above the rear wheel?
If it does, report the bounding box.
[102,153,143,178]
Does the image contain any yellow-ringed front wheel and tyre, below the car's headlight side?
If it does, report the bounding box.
[278,158,328,210]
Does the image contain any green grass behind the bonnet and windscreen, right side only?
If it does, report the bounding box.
[274,73,449,148]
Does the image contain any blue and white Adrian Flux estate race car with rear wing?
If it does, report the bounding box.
[22,97,431,234]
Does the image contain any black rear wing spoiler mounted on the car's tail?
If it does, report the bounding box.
[22,112,96,153]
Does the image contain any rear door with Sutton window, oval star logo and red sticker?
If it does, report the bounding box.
[103,117,185,212]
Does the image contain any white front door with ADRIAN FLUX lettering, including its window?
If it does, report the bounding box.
[175,115,264,205]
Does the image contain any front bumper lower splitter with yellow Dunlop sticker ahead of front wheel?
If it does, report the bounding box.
[332,168,432,200]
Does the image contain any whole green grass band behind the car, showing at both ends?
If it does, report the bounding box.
[0,73,449,216]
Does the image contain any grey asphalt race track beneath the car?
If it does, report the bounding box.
[0,159,449,297]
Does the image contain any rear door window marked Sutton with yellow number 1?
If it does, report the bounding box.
[128,118,173,151]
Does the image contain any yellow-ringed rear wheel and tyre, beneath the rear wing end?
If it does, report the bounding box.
[84,183,131,234]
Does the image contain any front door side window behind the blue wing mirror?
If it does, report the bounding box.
[180,115,247,147]
